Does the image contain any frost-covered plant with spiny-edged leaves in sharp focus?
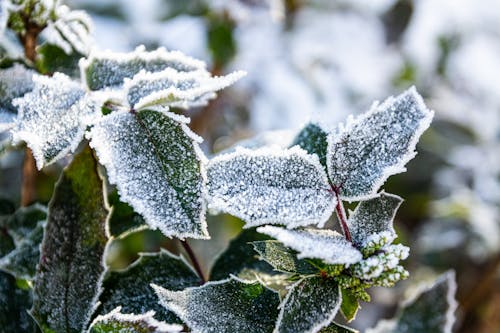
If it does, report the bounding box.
[0,0,458,333]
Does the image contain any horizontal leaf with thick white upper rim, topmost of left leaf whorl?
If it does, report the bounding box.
[80,46,206,90]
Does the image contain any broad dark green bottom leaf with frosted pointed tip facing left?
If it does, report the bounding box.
[152,277,279,333]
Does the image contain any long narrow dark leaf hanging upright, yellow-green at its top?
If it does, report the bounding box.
[31,146,108,332]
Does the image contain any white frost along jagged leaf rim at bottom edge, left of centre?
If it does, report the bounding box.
[89,306,182,333]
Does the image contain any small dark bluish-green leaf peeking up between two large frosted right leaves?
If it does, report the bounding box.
[291,123,328,169]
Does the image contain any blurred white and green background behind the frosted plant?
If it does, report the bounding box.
[0,0,500,333]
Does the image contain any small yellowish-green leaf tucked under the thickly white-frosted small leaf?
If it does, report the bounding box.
[252,240,318,275]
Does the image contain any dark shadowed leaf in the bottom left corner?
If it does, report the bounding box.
[0,271,36,333]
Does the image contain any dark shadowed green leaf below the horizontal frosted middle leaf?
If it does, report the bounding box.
[210,228,275,281]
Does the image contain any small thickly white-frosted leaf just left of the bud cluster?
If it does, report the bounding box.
[257,226,362,265]
